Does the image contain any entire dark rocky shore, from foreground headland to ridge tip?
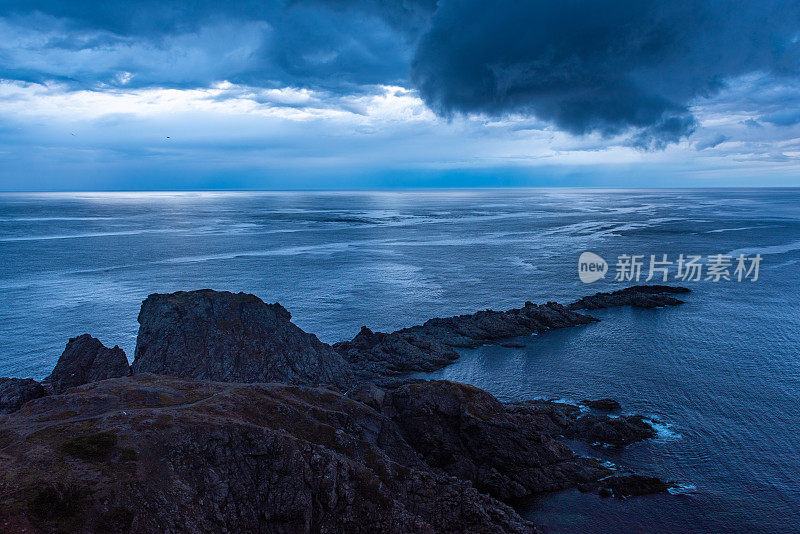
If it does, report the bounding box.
[0,286,687,532]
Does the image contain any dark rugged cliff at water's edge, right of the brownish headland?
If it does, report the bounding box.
[384,381,610,501]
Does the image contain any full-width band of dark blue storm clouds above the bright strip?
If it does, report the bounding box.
[0,0,800,148]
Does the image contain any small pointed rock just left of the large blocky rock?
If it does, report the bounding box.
[44,334,131,393]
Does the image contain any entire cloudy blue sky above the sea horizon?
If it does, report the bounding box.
[0,0,800,191]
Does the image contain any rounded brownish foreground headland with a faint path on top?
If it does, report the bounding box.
[0,374,534,533]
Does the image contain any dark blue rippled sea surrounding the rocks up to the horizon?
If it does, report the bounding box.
[0,189,800,532]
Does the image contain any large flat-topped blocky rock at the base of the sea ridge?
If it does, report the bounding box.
[132,289,353,387]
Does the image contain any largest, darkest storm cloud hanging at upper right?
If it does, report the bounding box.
[412,0,800,147]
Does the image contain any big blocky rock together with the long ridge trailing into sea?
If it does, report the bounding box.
[132,286,688,388]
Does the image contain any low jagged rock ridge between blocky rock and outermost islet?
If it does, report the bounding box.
[333,302,597,378]
